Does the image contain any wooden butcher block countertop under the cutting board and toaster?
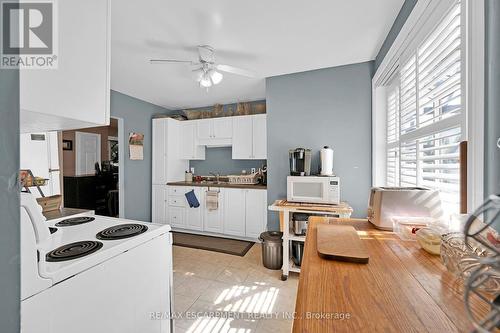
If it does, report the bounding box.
[293,217,489,333]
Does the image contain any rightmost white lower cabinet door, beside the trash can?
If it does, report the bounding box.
[245,190,267,238]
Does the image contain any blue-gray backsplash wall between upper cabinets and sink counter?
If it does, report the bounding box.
[189,147,266,175]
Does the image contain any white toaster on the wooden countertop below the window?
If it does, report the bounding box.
[368,187,443,230]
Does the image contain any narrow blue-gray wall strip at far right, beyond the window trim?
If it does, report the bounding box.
[484,0,500,198]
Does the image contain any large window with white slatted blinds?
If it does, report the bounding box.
[385,2,465,213]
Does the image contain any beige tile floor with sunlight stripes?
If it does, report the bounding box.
[173,244,298,333]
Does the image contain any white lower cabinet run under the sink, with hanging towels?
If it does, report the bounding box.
[159,185,267,239]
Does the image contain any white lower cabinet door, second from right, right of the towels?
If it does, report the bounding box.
[224,188,246,236]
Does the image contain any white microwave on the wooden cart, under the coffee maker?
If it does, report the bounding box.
[286,176,340,205]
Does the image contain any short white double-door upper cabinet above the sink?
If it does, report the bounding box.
[195,118,233,146]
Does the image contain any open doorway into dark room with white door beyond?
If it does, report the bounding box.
[62,118,123,217]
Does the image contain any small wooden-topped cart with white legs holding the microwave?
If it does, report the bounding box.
[268,200,353,281]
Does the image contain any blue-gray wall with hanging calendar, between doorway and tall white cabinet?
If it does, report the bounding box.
[111,91,173,221]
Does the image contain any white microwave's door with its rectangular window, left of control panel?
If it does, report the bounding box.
[287,177,329,203]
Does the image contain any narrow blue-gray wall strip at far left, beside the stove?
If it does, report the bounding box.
[0,64,20,326]
